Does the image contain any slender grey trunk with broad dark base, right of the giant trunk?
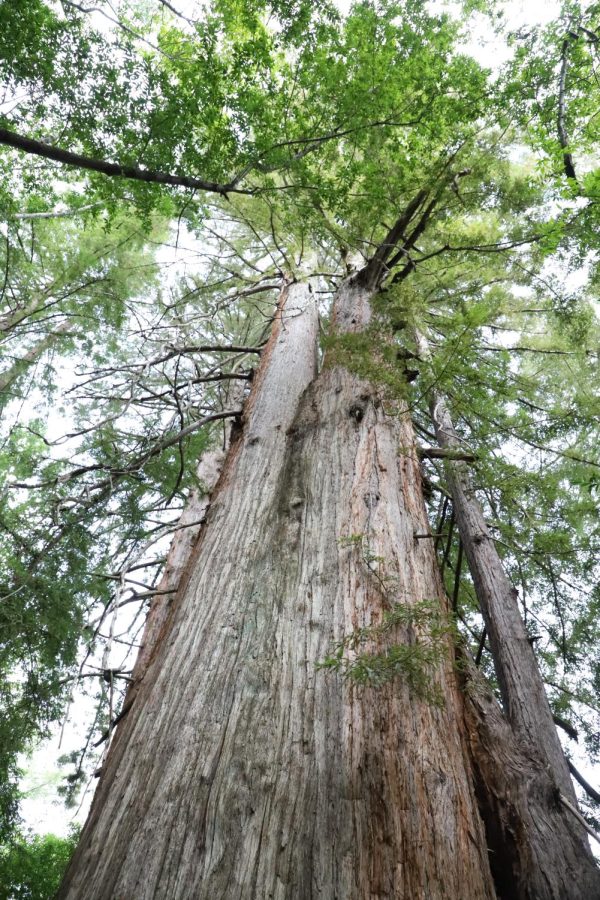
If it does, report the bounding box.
[417,334,600,900]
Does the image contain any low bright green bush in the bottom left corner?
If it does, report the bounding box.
[0,829,79,900]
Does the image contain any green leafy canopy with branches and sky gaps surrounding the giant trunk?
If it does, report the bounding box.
[0,0,600,856]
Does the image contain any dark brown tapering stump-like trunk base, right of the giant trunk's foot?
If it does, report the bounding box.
[464,657,600,900]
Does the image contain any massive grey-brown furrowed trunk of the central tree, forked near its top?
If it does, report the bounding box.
[60,280,496,900]
